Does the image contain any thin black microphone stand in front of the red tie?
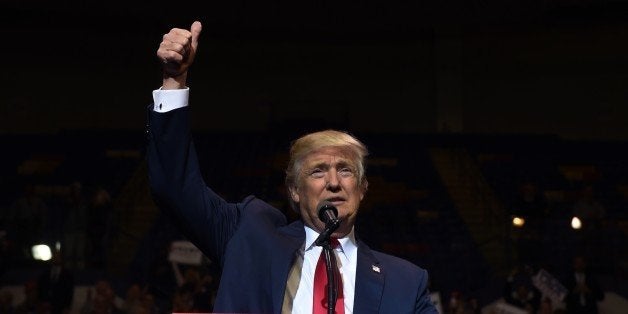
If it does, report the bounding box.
[314,219,340,314]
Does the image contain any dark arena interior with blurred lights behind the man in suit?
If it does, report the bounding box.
[0,0,628,314]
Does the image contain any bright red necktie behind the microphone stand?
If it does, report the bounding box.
[312,239,345,314]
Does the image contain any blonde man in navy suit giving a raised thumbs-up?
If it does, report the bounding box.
[147,22,437,314]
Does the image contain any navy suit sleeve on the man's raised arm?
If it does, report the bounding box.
[146,105,240,265]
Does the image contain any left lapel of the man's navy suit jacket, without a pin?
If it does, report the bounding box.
[270,221,305,313]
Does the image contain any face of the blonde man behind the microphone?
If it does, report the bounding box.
[290,147,365,238]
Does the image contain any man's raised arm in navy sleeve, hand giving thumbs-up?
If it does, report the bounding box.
[146,22,239,264]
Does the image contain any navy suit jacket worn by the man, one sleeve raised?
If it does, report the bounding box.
[147,107,437,314]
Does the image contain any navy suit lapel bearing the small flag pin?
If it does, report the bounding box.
[353,241,386,313]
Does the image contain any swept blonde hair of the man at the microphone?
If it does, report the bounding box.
[285,130,368,209]
